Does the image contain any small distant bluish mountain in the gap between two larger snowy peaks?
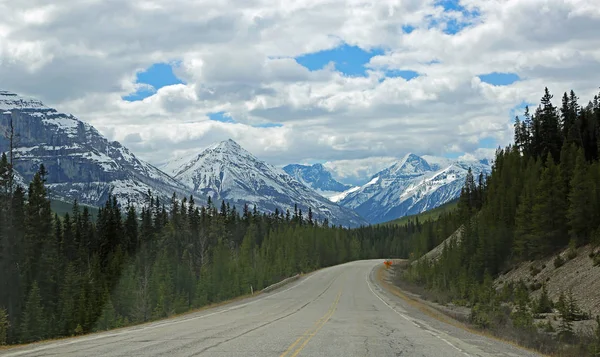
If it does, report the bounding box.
[283,164,352,202]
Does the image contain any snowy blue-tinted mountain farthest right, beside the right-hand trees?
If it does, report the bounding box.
[339,154,491,223]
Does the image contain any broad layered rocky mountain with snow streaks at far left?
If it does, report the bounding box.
[0,91,189,210]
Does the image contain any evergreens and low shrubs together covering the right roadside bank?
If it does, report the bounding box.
[394,89,600,356]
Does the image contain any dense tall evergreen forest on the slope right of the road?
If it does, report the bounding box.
[405,88,600,356]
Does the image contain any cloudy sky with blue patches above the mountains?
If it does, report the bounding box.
[0,0,600,183]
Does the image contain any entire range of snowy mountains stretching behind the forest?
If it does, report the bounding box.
[0,91,490,227]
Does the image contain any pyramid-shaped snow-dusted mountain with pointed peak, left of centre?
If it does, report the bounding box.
[162,140,366,227]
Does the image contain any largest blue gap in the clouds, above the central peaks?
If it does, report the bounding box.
[295,44,384,76]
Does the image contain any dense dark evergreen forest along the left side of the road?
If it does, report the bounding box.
[0,155,458,344]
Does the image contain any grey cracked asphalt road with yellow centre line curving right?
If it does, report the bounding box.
[0,260,537,357]
